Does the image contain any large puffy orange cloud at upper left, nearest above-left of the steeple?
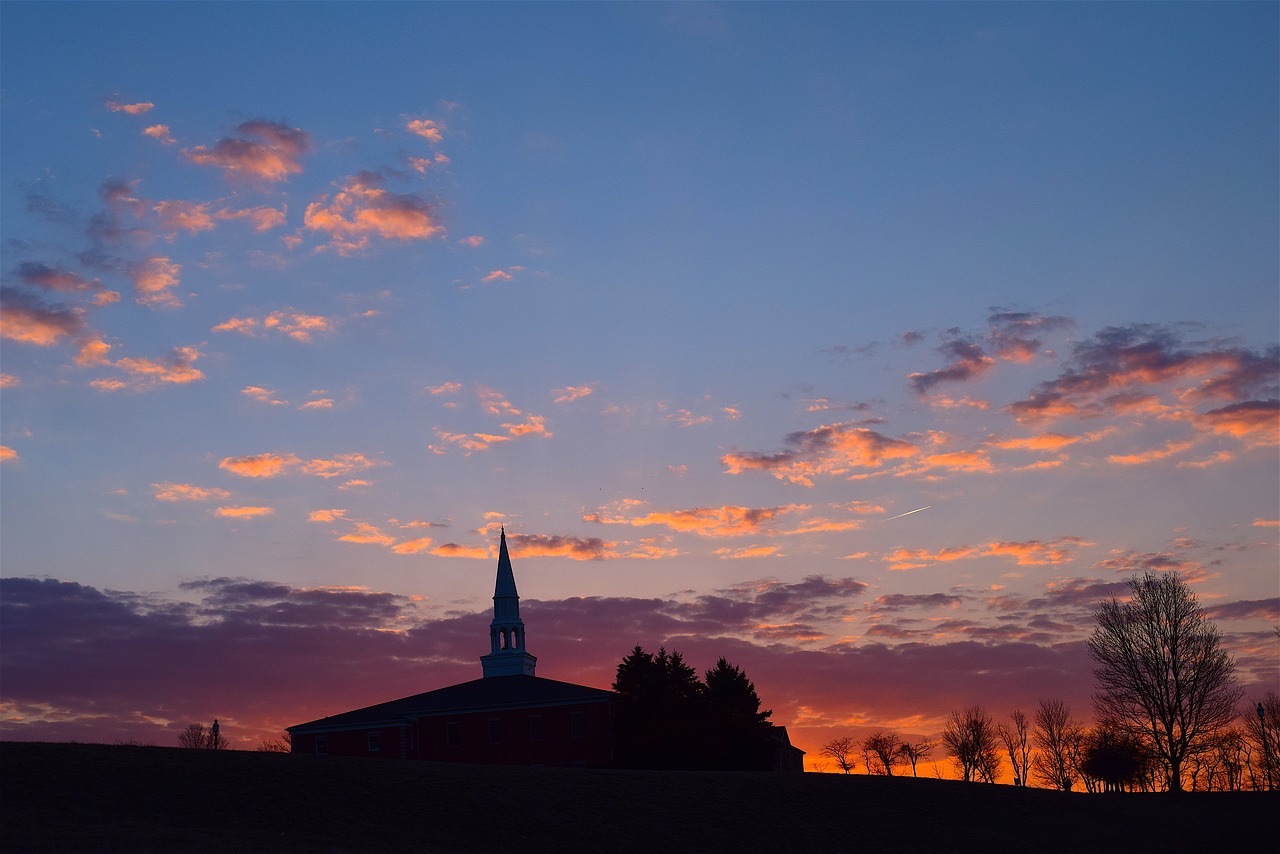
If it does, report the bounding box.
[303,172,444,255]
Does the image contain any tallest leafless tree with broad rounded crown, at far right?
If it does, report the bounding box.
[1088,572,1242,791]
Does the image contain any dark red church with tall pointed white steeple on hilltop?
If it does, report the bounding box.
[288,531,613,767]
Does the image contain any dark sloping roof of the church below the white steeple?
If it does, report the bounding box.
[288,676,613,732]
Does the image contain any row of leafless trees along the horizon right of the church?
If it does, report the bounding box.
[822,572,1280,793]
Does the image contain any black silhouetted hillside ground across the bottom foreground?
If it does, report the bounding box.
[0,743,1280,854]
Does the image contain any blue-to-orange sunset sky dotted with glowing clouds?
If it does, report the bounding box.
[0,3,1280,768]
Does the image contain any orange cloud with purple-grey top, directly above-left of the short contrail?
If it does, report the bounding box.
[721,423,920,487]
